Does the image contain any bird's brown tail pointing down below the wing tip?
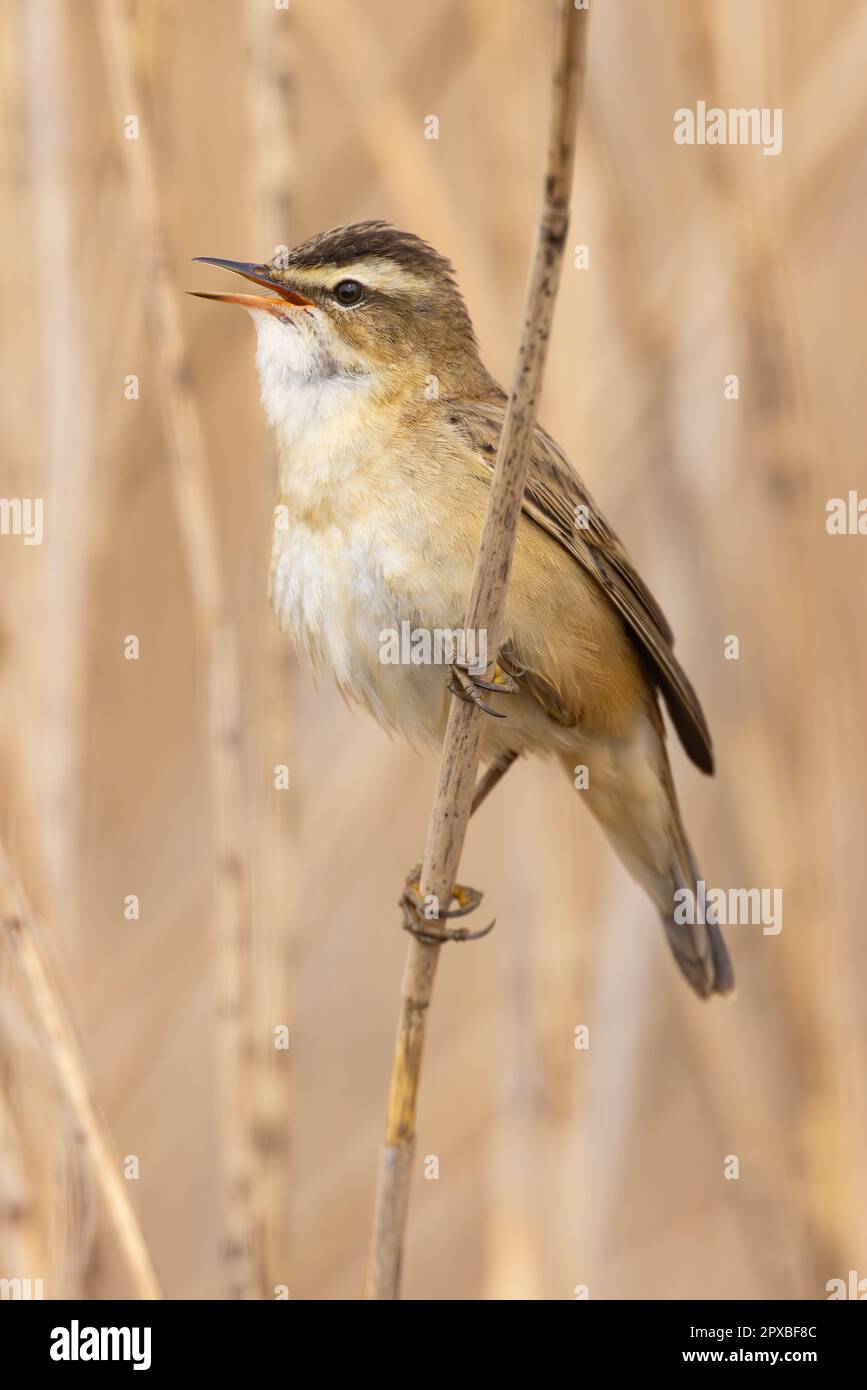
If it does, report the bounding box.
[564,727,735,999]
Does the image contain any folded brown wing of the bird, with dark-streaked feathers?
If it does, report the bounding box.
[449,402,713,773]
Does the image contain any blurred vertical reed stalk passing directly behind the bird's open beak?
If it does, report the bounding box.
[246,0,299,1293]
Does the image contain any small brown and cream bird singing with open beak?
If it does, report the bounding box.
[190,220,734,998]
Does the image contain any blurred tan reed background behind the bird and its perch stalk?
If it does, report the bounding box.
[0,0,867,1298]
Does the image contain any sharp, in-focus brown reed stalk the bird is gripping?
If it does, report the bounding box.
[364,0,589,1300]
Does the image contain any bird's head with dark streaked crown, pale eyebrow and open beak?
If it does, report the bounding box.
[195,222,489,395]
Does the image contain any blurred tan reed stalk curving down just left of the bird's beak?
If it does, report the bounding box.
[100,0,258,1298]
